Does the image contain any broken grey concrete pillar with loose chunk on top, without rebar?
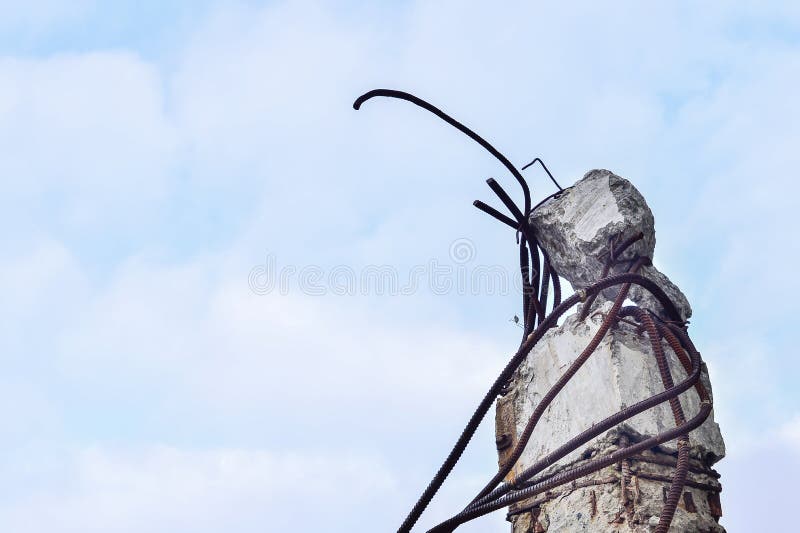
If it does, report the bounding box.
[496,170,725,533]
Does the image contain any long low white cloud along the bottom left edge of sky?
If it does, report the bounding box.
[0,446,395,533]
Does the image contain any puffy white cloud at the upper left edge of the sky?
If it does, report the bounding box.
[0,52,177,228]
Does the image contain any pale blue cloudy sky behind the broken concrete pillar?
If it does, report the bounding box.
[0,0,800,533]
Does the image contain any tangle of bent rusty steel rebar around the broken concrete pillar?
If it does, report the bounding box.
[353,89,713,533]
